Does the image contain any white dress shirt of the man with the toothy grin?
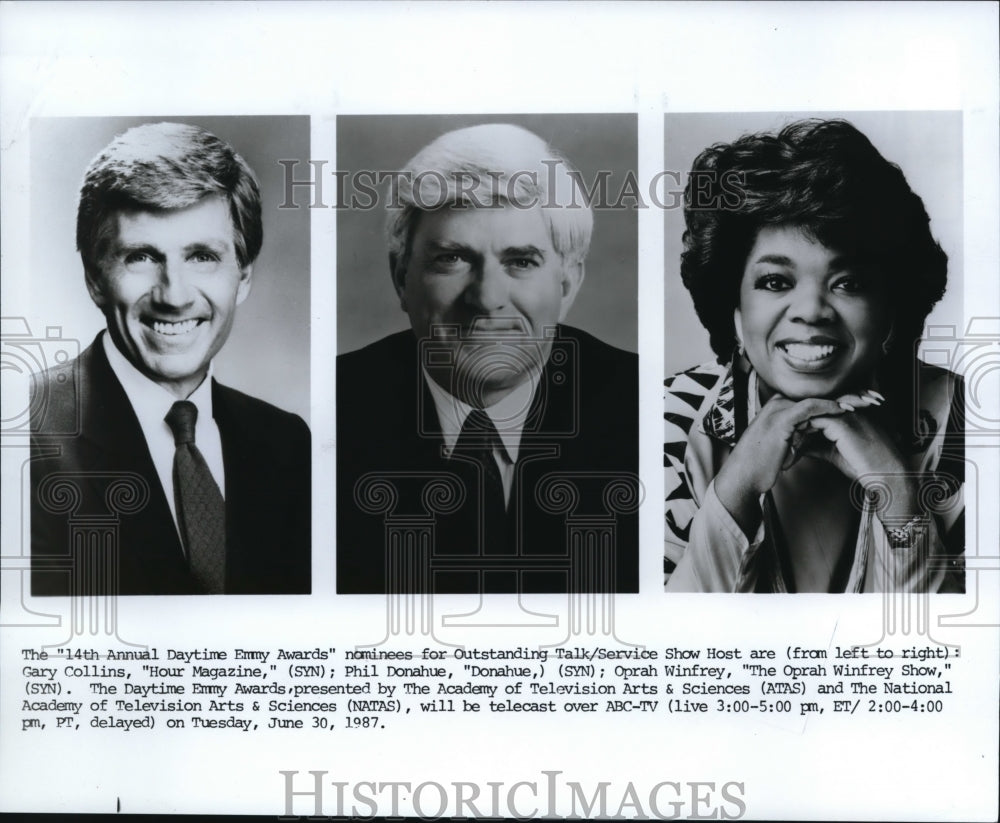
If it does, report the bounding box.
[101,332,226,534]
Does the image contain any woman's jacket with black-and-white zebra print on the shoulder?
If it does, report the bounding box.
[663,362,965,592]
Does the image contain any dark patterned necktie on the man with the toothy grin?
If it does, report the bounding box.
[164,400,226,594]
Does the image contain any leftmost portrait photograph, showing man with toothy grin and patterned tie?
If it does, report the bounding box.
[30,117,311,596]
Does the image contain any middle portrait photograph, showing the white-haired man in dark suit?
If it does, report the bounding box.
[337,114,639,594]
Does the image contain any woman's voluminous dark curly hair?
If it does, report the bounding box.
[681,120,948,374]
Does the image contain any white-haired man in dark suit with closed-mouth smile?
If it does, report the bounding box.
[337,124,639,593]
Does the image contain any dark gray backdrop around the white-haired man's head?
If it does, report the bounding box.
[332,114,638,353]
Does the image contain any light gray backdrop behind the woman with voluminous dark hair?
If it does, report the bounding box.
[663,111,964,375]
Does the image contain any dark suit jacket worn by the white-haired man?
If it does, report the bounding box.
[337,326,639,594]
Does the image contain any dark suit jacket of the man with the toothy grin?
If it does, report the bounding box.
[31,338,311,595]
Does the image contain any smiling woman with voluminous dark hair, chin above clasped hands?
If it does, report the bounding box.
[664,120,964,592]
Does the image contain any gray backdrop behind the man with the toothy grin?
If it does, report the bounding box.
[30,115,310,421]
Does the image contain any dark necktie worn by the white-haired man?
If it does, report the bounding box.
[453,409,511,554]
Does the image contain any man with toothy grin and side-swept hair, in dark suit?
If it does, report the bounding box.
[31,123,311,595]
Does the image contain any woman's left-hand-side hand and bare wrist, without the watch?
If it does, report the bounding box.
[715,395,848,536]
